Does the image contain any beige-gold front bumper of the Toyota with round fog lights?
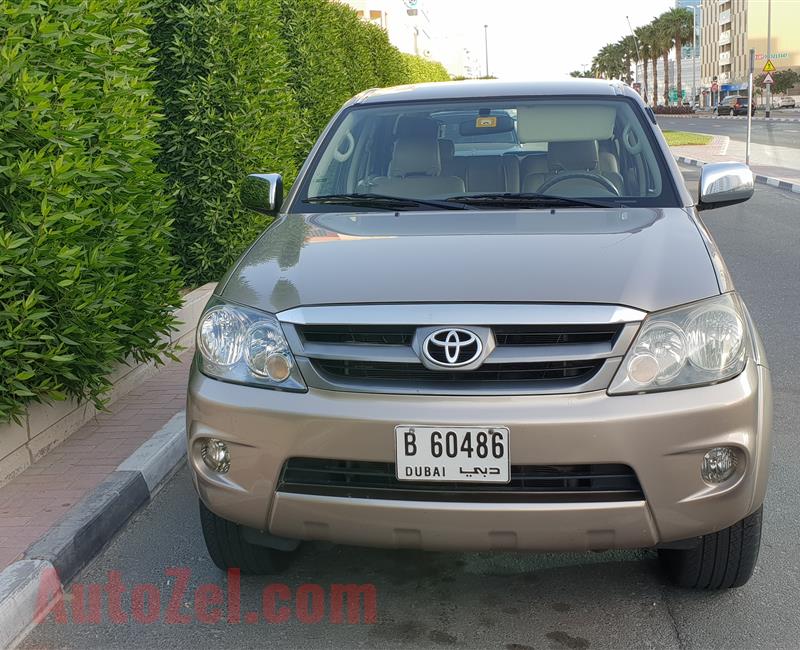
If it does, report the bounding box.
[187,361,772,550]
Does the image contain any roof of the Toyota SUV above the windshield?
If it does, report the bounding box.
[347,79,639,105]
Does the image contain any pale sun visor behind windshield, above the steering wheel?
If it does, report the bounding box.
[517,102,617,144]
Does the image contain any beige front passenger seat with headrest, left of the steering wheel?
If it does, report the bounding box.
[369,135,464,199]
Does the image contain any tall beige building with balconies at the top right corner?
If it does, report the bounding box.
[700,0,800,106]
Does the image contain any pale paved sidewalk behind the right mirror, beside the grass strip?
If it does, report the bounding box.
[670,136,800,184]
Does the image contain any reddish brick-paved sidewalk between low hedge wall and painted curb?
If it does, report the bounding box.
[0,349,193,570]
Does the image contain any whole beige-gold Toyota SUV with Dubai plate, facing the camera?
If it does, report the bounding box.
[186,79,772,589]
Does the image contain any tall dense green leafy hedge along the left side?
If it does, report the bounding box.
[0,0,446,421]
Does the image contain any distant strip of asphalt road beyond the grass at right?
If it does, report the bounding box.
[656,111,800,149]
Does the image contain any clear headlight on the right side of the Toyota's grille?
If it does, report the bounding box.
[608,293,749,394]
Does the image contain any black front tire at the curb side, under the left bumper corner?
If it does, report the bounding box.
[200,501,293,575]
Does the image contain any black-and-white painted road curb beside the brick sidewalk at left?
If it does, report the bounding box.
[0,411,186,648]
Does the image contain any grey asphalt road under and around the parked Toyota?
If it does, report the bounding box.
[22,170,800,650]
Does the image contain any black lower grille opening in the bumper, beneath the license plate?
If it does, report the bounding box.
[277,458,644,503]
